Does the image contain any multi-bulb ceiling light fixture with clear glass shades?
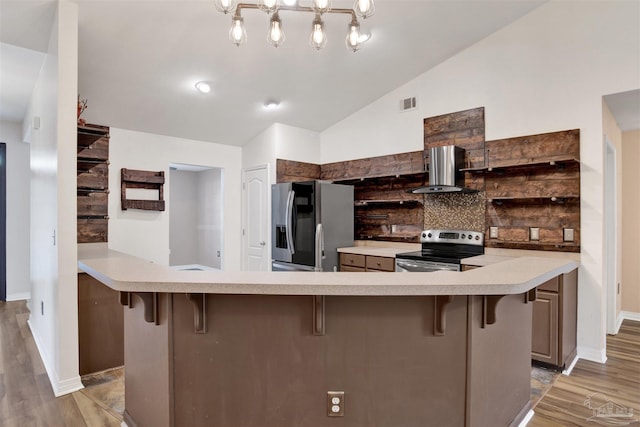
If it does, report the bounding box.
[214,0,375,52]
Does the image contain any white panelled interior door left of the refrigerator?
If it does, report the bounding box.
[242,166,271,271]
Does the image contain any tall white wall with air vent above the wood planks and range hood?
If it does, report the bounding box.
[321,1,640,361]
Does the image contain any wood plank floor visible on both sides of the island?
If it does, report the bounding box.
[0,301,640,427]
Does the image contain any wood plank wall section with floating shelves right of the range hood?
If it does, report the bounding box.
[480,129,580,252]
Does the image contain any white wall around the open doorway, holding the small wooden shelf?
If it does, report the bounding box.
[109,128,242,271]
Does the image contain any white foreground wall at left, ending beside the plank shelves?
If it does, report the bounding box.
[25,0,82,395]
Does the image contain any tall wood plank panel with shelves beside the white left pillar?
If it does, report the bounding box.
[76,124,109,243]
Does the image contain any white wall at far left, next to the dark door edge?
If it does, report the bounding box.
[0,121,31,301]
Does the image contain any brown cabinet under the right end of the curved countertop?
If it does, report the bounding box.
[531,270,578,369]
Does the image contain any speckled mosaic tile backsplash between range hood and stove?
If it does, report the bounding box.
[424,191,485,232]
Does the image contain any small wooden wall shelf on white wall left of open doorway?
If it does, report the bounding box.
[120,168,164,211]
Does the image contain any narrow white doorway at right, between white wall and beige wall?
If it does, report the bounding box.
[604,137,618,334]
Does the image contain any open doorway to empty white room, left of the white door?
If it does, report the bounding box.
[169,163,224,271]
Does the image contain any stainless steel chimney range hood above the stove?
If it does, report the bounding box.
[408,145,477,194]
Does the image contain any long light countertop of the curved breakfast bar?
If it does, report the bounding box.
[78,244,578,296]
